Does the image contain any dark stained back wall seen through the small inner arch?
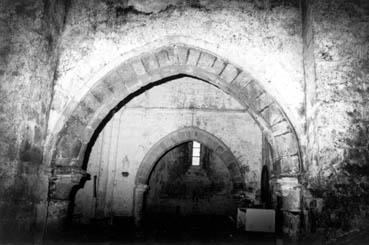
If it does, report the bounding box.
[145,142,236,218]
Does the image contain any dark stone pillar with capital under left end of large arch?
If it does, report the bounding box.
[46,170,86,235]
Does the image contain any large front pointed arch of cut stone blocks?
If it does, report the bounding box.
[44,44,302,237]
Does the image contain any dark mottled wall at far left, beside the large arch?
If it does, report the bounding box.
[0,0,64,239]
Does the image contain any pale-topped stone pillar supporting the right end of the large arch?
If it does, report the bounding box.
[276,177,302,240]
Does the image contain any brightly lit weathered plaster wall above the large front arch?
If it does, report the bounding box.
[49,1,304,145]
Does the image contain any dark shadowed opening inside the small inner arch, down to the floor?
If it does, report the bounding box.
[145,142,236,231]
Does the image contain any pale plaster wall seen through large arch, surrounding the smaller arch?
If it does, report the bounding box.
[76,77,262,222]
